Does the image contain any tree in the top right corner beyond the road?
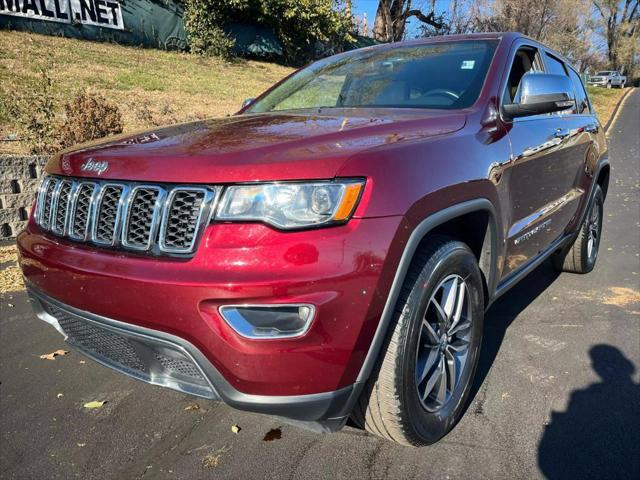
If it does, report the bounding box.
[593,0,640,71]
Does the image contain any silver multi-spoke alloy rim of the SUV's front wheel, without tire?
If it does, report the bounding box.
[415,275,472,412]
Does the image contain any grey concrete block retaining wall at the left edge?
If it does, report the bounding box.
[0,154,49,240]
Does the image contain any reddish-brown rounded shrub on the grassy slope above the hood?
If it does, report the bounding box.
[59,91,123,148]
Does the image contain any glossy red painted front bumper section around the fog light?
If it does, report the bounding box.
[18,217,404,400]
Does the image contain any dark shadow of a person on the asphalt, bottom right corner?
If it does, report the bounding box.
[538,345,640,479]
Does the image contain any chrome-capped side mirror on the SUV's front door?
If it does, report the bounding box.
[502,72,575,118]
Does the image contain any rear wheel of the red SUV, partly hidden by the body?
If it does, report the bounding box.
[552,185,604,273]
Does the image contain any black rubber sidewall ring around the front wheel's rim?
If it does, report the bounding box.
[399,242,484,444]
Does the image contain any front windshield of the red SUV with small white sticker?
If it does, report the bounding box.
[247,40,497,113]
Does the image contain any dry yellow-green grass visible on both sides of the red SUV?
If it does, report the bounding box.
[0,31,624,153]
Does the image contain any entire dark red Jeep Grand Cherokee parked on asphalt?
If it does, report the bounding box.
[18,33,609,445]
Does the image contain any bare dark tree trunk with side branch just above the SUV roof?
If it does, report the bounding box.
[373,0,442,42]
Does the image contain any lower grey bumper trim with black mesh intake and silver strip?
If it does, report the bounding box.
[27,285,358,430]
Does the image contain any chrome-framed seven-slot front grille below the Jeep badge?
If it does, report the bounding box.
[35,176,218,255]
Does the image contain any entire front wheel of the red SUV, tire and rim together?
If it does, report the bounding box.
[352,236,484,446]
